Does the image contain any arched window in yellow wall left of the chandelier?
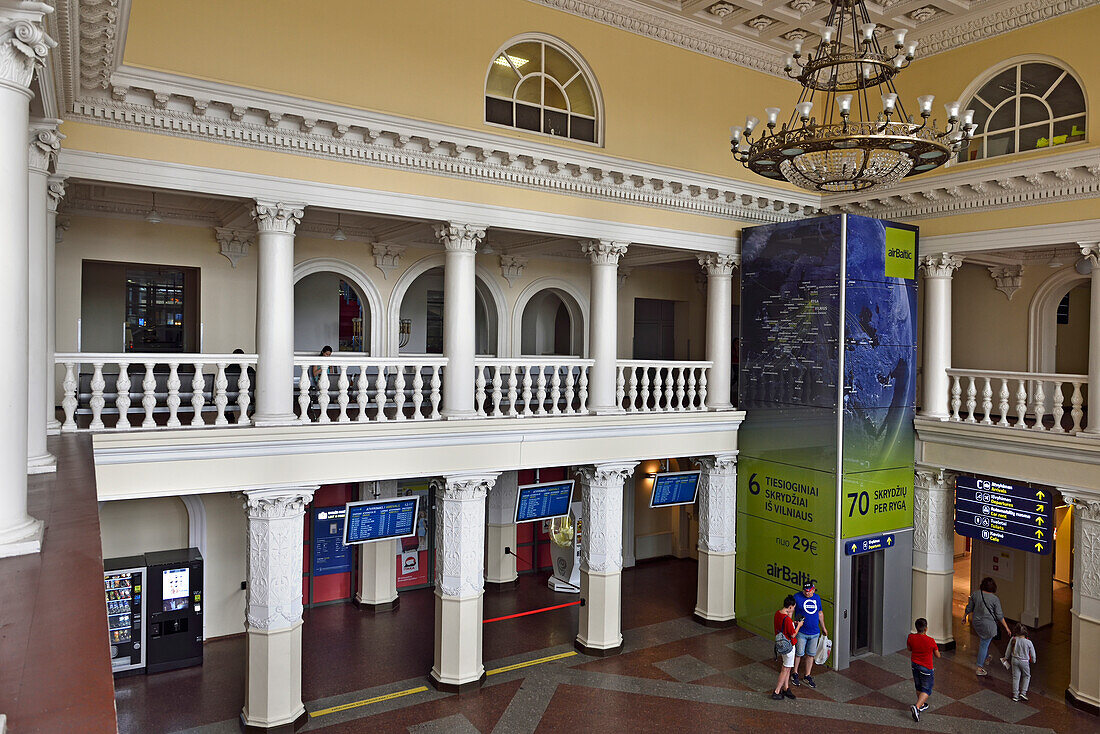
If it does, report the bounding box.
[485,36,601,143]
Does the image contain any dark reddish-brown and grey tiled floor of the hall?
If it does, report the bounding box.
[118,560,1100,734]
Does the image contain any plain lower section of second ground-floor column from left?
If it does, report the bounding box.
[429,590,485,693]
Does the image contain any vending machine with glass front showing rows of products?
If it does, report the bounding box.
[103,556,145,676]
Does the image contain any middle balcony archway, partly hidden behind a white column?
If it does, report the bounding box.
[397,267,499,355]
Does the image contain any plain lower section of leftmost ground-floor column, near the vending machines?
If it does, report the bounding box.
[241,621,306,732]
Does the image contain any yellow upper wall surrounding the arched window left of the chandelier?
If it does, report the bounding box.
[124,0,798,187]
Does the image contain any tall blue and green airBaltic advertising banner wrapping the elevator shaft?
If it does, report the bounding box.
[735,215,917,636]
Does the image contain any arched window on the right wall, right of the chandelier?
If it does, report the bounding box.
[959,61,1085,161]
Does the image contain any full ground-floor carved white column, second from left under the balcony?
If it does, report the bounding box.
[429,473,496,692]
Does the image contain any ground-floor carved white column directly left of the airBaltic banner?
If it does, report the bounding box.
[694,452,737,627]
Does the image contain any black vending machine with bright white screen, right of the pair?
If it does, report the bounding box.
[144,548,202,672]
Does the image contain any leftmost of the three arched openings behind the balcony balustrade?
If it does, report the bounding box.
[294,271,371,354]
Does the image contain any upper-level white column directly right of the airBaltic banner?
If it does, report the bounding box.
[921,252,963,420]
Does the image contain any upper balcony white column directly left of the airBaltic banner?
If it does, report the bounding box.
[699,253,740,410]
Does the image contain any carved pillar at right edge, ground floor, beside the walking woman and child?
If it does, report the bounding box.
[1062,490,1100,713]
